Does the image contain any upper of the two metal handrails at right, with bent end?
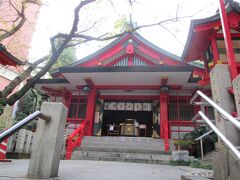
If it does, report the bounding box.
[190,90,240,129]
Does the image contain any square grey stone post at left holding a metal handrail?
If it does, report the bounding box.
[27,102,67,178]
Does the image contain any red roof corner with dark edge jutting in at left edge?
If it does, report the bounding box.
[0,44,25,66]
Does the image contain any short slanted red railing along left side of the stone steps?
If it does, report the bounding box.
[66,120,86,159]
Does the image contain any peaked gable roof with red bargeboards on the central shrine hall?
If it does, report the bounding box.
[50,32,203,77]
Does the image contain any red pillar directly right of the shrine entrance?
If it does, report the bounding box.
[159,92,169,151]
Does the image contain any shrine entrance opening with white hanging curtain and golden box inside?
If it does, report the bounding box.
[102,101,153,137]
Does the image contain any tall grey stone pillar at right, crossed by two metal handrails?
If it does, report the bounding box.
[210,64,240,180]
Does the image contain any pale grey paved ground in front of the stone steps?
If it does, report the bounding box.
[0,160,208,180]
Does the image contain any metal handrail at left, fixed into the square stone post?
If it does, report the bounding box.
[0,111,51,143]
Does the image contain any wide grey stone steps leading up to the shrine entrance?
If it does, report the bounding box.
[72,136,172,164]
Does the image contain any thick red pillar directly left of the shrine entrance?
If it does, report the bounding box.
[86,88,97,136]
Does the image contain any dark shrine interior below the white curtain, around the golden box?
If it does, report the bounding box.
[102,110,153,137]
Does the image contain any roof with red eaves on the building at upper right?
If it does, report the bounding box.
[181,0,240,62]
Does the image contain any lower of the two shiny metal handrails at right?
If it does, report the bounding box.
[198,111,240,160]
